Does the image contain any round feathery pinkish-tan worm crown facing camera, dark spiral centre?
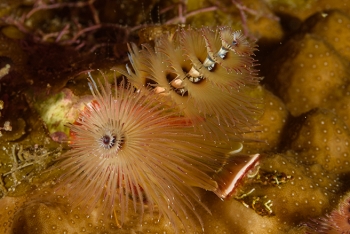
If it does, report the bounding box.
[59,74,239,231]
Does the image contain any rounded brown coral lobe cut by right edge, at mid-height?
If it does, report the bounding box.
[285,109,350,173]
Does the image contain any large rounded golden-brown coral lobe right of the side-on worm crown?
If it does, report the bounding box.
[268,33,348,116]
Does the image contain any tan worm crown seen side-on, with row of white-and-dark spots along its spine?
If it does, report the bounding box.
[118,27,261,139]
